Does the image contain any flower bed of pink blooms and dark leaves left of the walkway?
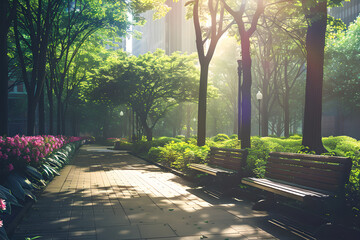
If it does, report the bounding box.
[0,135,87,239]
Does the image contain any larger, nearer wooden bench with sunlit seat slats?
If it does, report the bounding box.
[241,152,352,210]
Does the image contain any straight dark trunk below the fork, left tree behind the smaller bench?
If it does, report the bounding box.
[197,61,209,146]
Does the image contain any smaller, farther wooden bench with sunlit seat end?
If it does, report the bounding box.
[189,147,247,177]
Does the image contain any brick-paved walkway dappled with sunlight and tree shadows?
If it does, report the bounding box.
[12,145,308,240]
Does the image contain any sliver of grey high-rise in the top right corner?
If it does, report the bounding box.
[329,0,360,26]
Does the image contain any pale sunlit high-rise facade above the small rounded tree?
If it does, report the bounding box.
[132,0,196,56]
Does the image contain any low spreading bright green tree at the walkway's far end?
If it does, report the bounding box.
[128,50,197,141]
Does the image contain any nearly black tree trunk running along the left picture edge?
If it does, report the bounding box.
[0,0,9,136]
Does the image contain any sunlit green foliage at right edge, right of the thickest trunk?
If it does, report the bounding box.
[324,15,360,109]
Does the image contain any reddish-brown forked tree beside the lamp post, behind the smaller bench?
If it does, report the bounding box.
[222,0,264,149]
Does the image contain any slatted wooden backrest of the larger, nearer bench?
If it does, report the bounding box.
[265,152,351,192]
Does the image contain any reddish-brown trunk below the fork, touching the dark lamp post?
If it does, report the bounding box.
[240,32,252,149]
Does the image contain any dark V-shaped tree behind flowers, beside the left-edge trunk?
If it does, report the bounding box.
[14,0,62,135]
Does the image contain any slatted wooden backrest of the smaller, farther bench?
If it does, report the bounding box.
[208,147,247,172]
